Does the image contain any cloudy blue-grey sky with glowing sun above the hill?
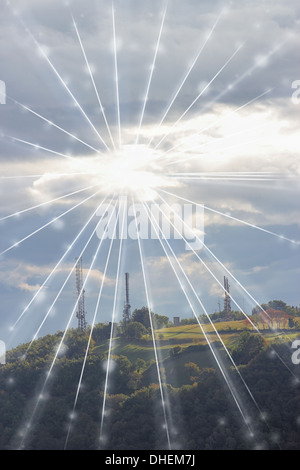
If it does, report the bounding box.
[0,0,300,345]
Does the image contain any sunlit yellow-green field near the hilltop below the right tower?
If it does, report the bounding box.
[93,321,299,386]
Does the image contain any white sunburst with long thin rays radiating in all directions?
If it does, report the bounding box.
[0,0,300,450]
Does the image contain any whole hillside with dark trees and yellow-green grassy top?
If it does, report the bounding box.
[0,321,300,449]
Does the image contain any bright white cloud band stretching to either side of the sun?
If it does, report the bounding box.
[2,97,300,233]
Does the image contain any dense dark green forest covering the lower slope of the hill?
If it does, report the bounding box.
[0,302,300,450]
